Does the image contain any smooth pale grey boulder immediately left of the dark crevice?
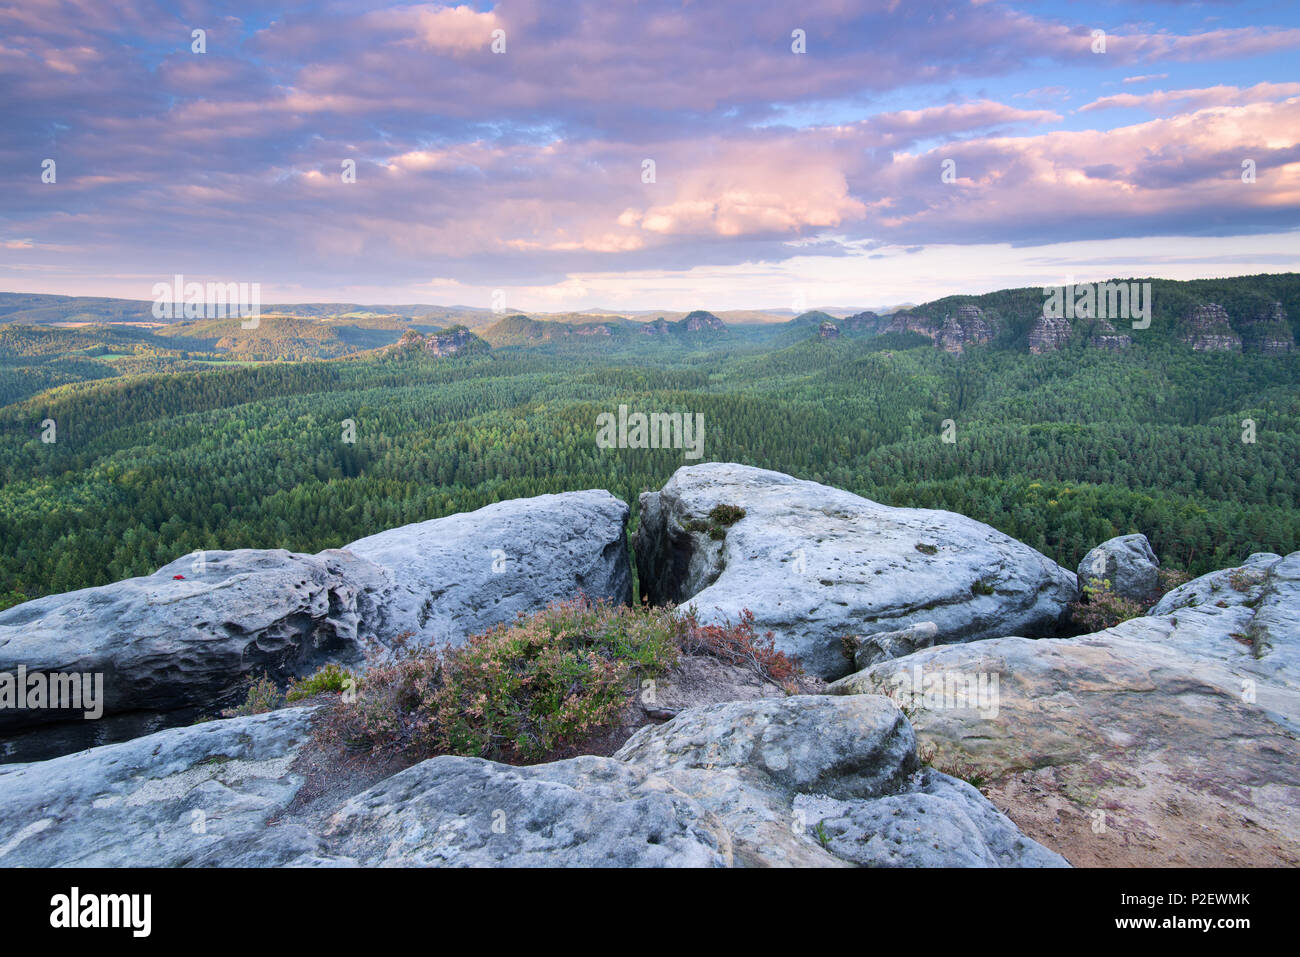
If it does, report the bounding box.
[345,490,632,644]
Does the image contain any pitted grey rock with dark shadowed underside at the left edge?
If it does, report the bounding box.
[0,549,386,761]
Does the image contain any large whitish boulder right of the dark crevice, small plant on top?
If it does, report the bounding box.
[634,463,1076,679]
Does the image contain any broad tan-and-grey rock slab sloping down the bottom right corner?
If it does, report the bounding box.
[828,553,1300,866]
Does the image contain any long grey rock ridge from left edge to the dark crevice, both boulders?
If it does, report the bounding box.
[0,492,632,761]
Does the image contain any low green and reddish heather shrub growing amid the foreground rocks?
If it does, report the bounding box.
[319,599,686,762]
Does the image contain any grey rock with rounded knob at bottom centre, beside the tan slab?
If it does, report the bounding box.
[615,696,1065,866]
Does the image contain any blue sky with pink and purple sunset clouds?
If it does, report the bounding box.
[0,0,1300,312]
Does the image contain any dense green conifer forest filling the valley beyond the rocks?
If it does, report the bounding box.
[0,281,1300,605]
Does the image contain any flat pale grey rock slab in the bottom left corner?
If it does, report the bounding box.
[0,707,315,867]
